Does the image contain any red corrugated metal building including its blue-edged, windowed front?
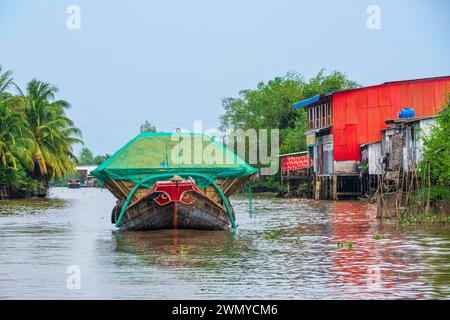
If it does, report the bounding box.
[293,76,450,175]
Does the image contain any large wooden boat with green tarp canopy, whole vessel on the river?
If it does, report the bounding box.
[92,132,259,231]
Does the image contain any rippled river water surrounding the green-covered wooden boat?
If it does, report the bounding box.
[0,188,450,299]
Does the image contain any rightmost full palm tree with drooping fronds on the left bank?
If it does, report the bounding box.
[20,79,83,181]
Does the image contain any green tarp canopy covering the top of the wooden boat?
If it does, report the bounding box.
[91,132,259,188]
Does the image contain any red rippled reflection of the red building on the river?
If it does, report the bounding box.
[329,202,450,299]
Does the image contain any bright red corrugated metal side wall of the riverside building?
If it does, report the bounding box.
[331,77,450,161]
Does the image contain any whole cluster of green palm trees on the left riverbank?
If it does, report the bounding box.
[0,66,82,195]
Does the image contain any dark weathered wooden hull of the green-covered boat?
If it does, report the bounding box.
[112,196,230,231]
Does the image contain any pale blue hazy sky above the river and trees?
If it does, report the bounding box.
[0,0,450,154]
